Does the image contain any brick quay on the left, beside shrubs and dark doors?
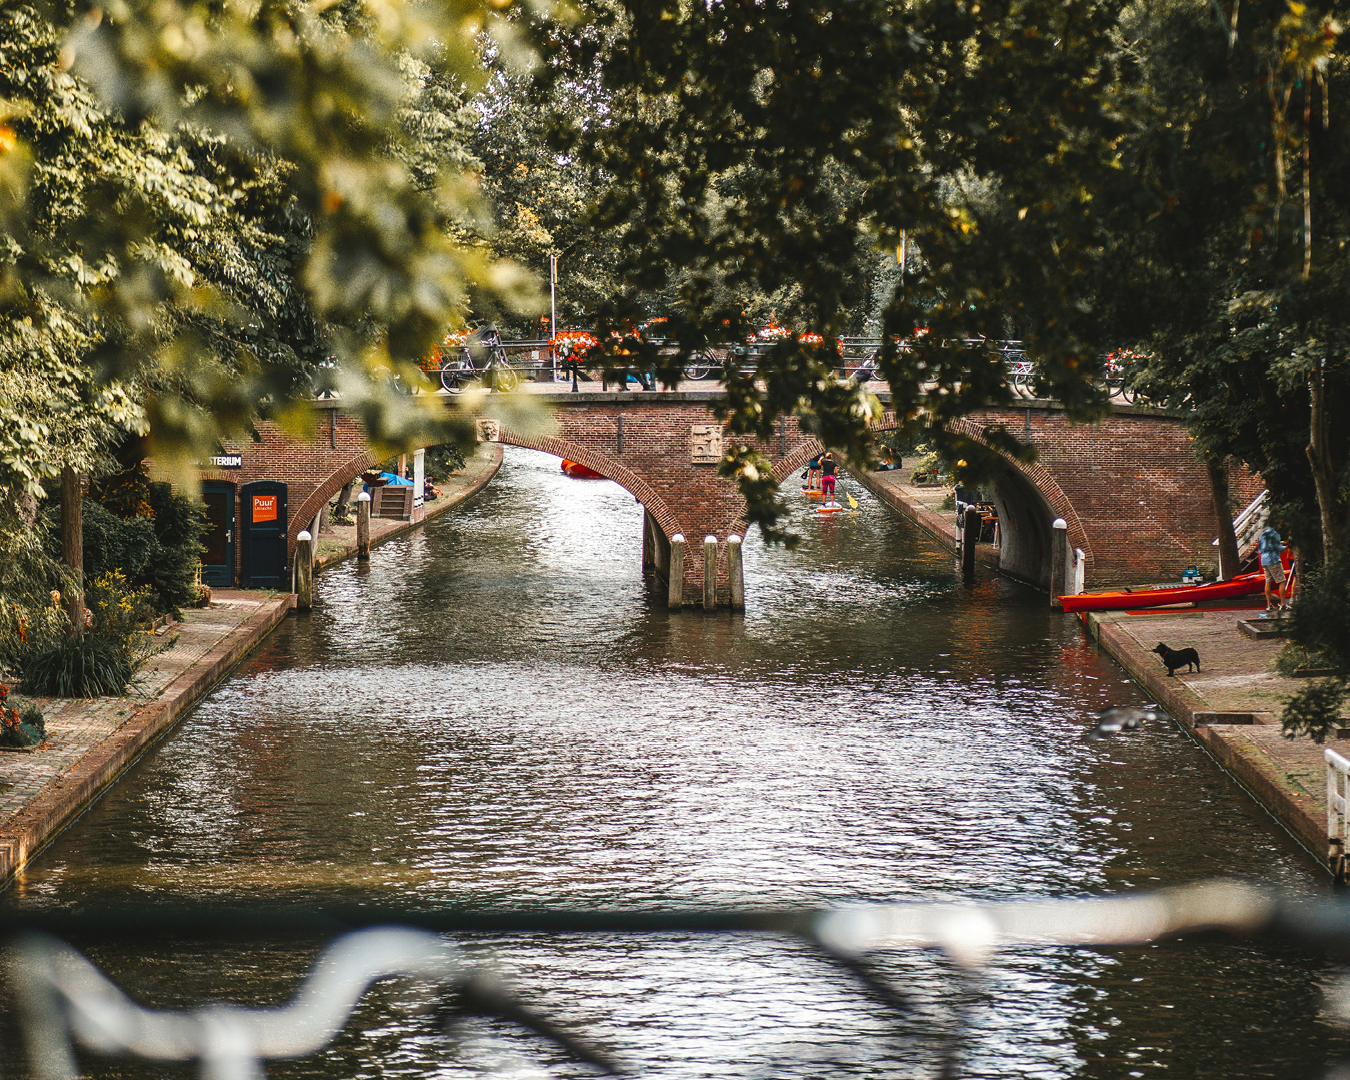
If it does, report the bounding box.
[0,589,290,886]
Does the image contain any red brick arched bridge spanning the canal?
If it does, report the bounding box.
[203,389,1260,606]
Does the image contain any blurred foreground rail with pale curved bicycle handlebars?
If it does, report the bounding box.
[5,885,1350,1080]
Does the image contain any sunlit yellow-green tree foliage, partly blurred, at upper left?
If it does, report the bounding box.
[0,0,547,507]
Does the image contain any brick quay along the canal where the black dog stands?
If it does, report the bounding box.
[1081,609,1327,867]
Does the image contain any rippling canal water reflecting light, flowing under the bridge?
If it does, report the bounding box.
[2,450,1350,1080]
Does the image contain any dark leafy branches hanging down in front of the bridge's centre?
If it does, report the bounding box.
[545,0,1126,536]
